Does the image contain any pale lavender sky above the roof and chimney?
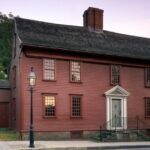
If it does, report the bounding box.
[0,0,150,38]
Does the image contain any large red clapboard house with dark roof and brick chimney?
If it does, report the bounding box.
[8,7,150,139]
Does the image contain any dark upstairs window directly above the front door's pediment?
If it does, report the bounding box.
[111,65,120,85]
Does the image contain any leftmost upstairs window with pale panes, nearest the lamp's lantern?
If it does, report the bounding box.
[43,59,55,81]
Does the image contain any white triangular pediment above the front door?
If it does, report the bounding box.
[105,85,130,97]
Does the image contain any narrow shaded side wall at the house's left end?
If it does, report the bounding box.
[10,28,22,131]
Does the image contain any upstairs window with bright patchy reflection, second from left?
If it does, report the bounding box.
[70,61,81,82]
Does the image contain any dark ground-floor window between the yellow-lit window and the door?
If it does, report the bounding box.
[71,95,82,118]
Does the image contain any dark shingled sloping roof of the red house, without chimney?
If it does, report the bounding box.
[15,18,150,60]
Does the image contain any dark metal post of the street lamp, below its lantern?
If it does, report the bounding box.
[29,87,35,148]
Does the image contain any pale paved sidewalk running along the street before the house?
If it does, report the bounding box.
[0,141,150,150]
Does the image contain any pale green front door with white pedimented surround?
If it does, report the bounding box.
[105,85,130,130]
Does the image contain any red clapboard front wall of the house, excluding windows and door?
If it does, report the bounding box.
[18,49,150,139]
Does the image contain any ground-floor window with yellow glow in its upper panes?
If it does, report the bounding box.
[43,94,56,117]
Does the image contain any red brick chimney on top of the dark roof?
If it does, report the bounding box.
[83,7,103,31]
